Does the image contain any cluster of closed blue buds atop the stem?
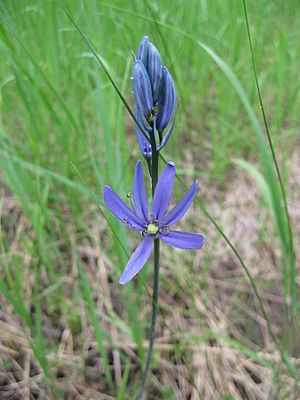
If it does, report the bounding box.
[132,36,176,158]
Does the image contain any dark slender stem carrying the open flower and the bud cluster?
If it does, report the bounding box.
[137,126,160,400]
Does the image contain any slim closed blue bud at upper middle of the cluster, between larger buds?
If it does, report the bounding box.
[147,43,162,103]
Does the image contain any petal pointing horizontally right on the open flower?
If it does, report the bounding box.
[160,231,205,250]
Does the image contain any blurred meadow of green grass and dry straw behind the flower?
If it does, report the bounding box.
[0,0,300,400]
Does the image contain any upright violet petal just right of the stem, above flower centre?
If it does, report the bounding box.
[151,161,176,221]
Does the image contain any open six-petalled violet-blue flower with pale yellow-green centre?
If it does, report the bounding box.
[104,161,205,285]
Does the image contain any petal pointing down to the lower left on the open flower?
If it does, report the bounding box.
[119,237,153,285]
